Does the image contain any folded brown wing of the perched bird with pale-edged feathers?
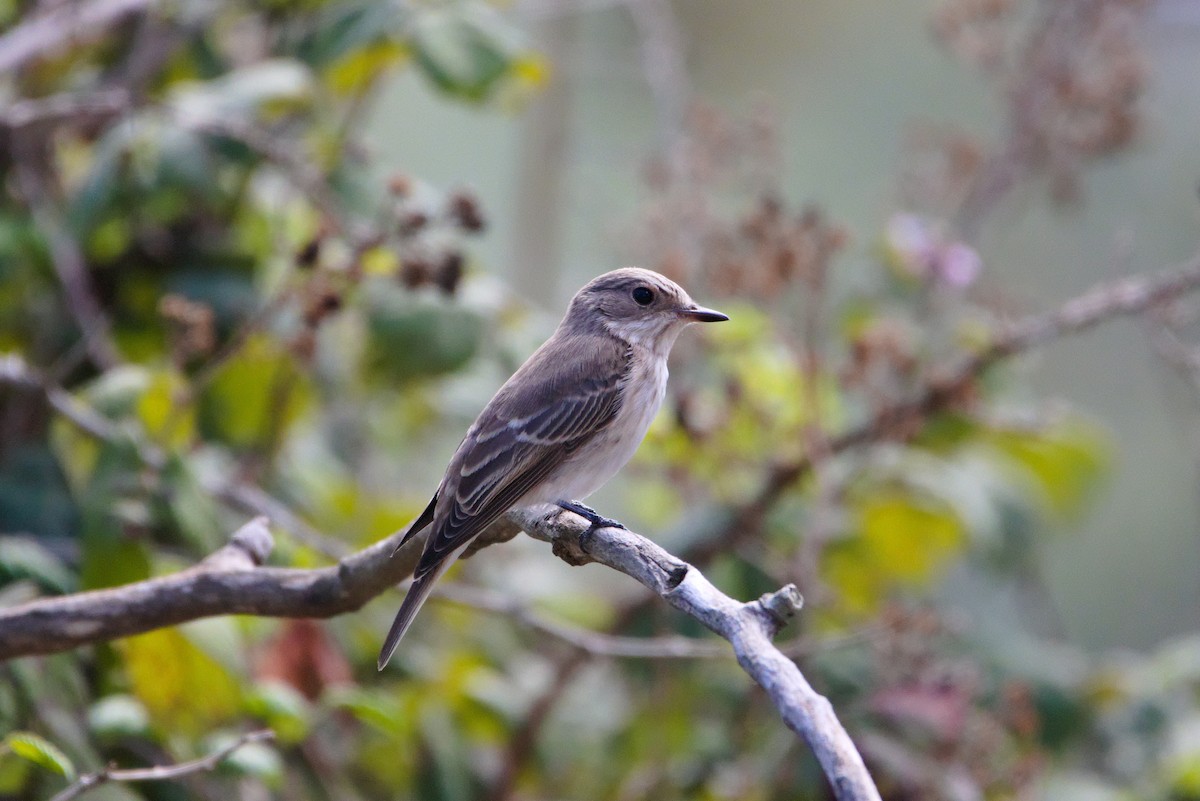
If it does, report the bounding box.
[414,336,631,578]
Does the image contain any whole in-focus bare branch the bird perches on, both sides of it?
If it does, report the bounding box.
[0,515,878,801]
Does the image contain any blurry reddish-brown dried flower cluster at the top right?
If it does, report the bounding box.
[921,0,1150,221]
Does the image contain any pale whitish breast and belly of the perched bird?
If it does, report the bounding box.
[518,359,667,505]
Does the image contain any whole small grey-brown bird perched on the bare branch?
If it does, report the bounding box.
[379,267,728,670]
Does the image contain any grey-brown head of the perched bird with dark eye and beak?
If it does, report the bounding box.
[564,267,730,354]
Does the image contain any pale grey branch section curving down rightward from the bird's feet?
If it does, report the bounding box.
[509,507,880,801]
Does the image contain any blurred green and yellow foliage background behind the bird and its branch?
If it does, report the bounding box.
[0,0,1200,801]
